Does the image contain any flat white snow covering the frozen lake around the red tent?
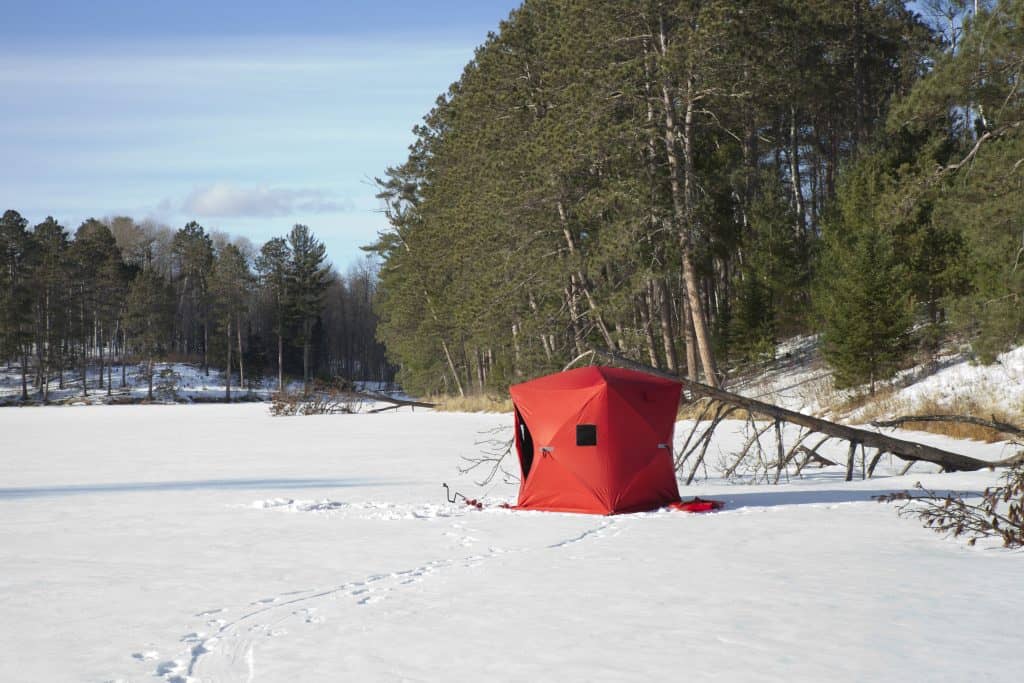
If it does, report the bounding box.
[0,403,1024,682]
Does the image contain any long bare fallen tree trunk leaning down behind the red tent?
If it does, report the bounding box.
[593,349,1021,472]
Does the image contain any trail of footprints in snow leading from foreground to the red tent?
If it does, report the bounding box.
[144,518,618,683]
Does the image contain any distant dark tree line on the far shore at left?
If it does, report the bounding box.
[0,210,393,401]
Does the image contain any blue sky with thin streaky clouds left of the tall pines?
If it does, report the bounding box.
[0,0,518,269]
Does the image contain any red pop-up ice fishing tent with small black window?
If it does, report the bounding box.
[510,367,682,515]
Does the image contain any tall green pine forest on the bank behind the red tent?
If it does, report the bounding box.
[372,0,1024,394]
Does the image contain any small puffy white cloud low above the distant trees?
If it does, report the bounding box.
[180,182,355,218]
